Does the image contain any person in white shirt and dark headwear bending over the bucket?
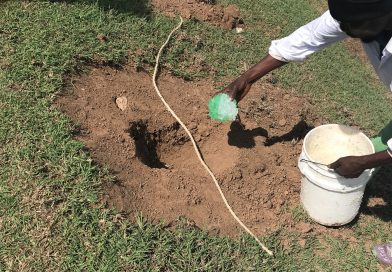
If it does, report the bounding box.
[223,0,392,178]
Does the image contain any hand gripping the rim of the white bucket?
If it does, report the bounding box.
[328,156,365,178]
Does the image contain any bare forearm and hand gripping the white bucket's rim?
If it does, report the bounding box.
[329,151,392,178]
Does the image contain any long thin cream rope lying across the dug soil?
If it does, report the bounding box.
[152,16,273,256]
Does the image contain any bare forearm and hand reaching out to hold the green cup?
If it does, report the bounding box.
[222,54,287,102]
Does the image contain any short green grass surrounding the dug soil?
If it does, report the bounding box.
[0,0,392,271]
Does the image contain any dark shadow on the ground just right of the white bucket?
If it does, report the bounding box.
[362,165,392,222]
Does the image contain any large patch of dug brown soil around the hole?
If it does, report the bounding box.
[56,67,328,235]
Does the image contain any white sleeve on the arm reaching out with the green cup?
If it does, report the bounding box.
[269,10,347,62]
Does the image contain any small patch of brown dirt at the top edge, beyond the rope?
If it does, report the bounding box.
[151,0,244,29]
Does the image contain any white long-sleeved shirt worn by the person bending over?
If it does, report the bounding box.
[269,11,392,153]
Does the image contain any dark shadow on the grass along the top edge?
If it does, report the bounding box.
[51,0,151,17]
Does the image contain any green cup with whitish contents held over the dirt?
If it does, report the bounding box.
[208,93,238,122]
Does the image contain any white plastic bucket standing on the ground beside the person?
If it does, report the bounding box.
[298,124,374,226]
